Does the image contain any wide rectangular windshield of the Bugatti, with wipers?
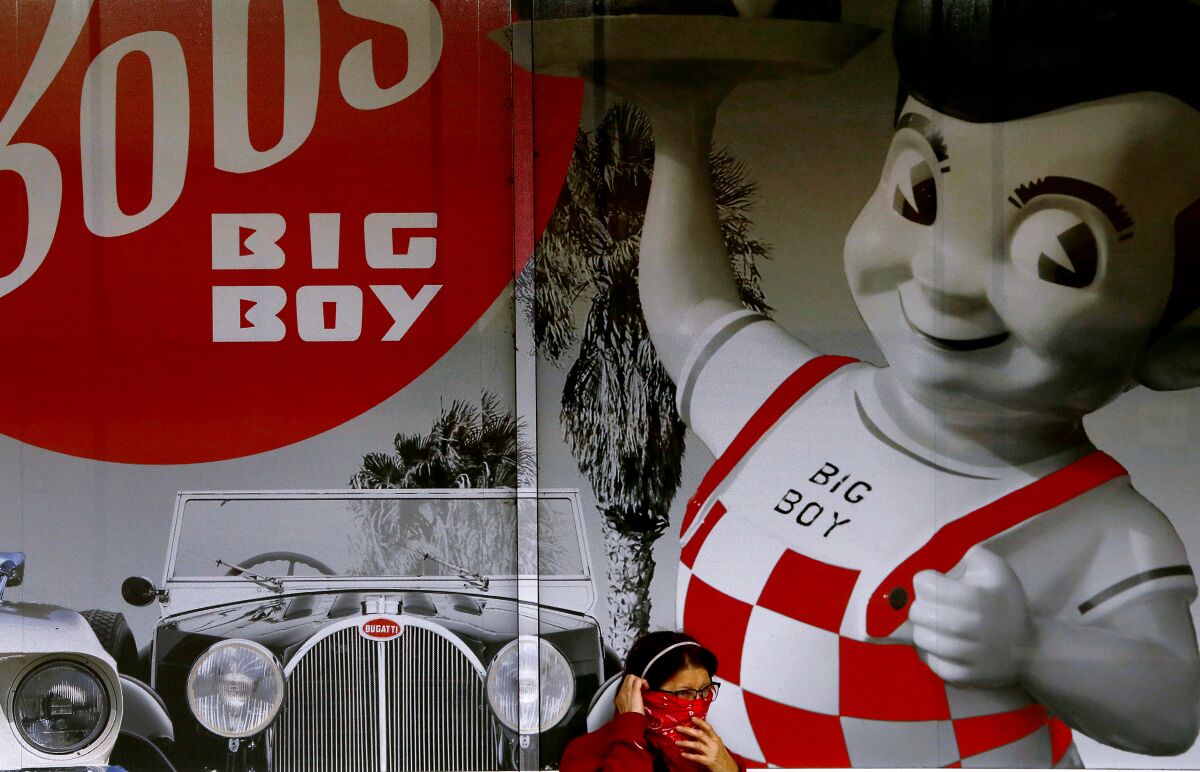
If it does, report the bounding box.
[170,495,584,581]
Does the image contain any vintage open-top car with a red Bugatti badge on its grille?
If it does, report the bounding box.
[122,489,616,772]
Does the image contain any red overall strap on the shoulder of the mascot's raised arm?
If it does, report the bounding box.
[679,355,858,537]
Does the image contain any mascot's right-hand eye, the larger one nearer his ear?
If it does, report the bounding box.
[1010,209,1100,289]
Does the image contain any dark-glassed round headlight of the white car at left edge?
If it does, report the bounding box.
[13,660,112,754]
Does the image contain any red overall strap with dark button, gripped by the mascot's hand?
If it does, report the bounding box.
[866,450,1127,638]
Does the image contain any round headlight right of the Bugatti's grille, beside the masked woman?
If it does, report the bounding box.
[487,635,575,735]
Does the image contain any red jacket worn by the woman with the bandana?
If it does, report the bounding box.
[559,712,745,772]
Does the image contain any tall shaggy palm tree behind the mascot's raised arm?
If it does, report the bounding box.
[528,103,769,651]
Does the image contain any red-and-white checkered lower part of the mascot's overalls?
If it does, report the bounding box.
[680,516,1070,767]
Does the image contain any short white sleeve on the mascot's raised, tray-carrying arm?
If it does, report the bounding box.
[676,311,818,456]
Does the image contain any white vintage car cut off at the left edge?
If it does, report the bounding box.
[0,552,172,772]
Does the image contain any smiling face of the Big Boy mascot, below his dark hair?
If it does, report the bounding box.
[845,94,1200,418]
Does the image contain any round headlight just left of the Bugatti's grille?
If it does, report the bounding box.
[187,640,283,737]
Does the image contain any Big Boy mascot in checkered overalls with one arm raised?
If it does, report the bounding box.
[630,0,1200,767]
